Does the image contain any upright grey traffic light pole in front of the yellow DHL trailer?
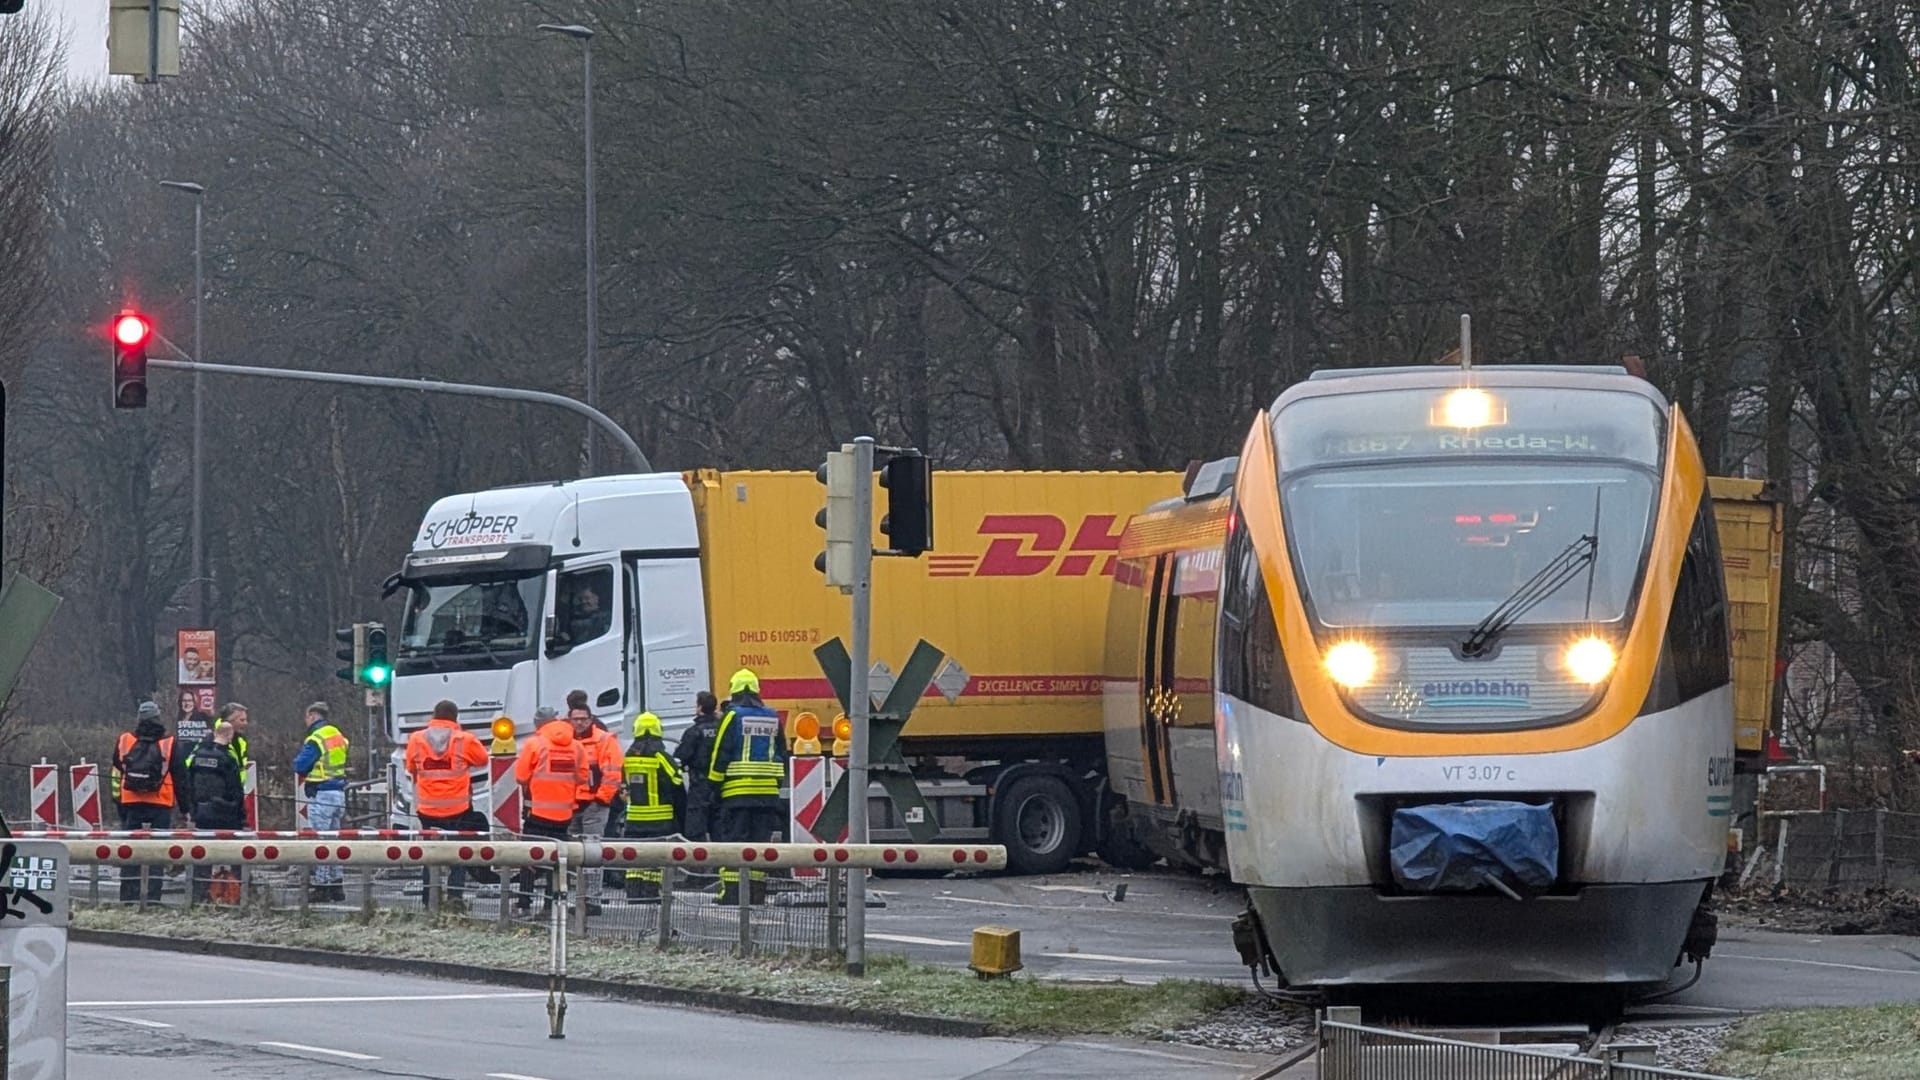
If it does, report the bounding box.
[847,434,874,976]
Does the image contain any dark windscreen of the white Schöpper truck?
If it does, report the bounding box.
[397,575,545,667]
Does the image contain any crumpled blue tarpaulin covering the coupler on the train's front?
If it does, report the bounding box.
[1388,799,1559,892]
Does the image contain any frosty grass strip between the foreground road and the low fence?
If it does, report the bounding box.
[73,905,1246,1038]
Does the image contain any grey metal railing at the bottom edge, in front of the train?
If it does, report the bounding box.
[1317,1009,1732,1080]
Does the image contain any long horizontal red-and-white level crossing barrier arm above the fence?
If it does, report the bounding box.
[65,836,1006,871]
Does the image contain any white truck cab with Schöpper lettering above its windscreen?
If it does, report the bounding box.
[386,473,710,811]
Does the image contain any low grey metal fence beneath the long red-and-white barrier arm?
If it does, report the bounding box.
[73,841,847,955]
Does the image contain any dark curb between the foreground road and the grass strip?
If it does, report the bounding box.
[67,928,995,1040]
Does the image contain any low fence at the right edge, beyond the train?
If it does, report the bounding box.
[1740,809,1920,890]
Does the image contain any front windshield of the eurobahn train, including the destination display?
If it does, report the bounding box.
[1275,388,1663,630]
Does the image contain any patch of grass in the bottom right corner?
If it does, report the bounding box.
[1713,1005,1920,1080]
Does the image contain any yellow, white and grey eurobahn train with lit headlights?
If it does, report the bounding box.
[1106,367,1734,988]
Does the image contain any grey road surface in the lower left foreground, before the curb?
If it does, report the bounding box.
[67,945,1260,1080]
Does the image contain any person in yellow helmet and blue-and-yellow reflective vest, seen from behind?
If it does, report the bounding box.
[707,667,787,903]
